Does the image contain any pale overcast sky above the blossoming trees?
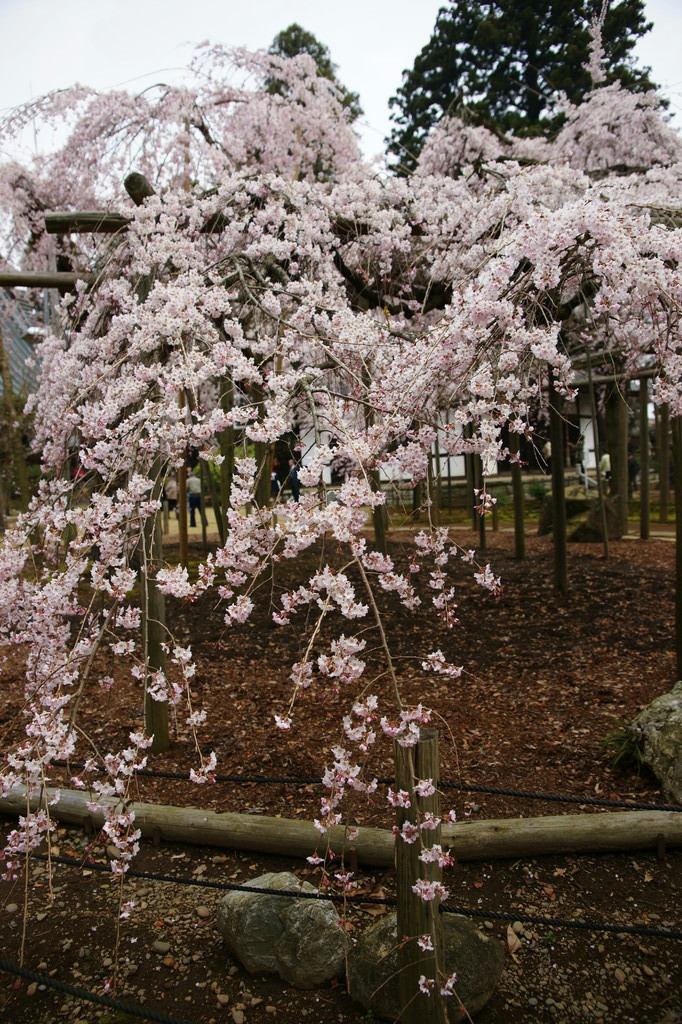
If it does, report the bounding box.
[0,0,682,156]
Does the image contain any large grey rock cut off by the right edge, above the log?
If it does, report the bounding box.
[630,682,682,804]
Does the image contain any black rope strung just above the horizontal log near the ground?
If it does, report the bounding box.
[42,761,682,813]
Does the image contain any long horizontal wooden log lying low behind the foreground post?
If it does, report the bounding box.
[0,785,682,867]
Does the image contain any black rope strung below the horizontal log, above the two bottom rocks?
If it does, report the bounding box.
[33,854,682,940]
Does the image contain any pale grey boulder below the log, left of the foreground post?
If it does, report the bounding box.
[217,871,344,988]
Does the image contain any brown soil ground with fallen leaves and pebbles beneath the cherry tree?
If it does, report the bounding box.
[0,531,682,1024]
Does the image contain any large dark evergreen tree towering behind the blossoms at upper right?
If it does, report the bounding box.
[388,0,654,171]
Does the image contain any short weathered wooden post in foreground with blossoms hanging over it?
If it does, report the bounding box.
[394,728,446,1024]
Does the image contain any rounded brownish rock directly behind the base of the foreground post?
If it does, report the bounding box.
[348,913,505,1021]
